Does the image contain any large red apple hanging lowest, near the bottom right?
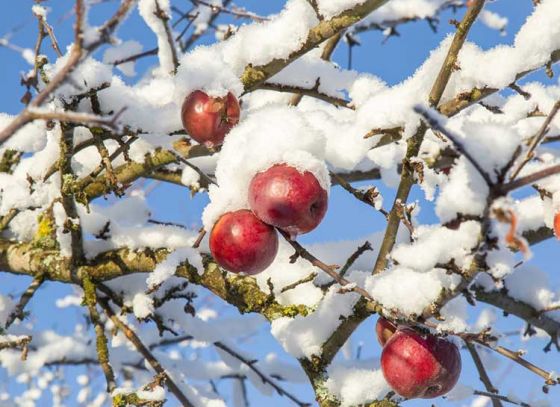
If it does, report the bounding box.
[381,327,461,399]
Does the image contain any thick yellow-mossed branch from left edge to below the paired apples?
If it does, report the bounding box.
[0,241,309,320]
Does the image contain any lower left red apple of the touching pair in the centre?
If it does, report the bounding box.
[210,209,278,274]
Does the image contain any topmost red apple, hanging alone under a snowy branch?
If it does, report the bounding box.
[181,90,240,147]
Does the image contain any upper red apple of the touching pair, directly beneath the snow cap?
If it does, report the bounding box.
[249,164,328,236]
